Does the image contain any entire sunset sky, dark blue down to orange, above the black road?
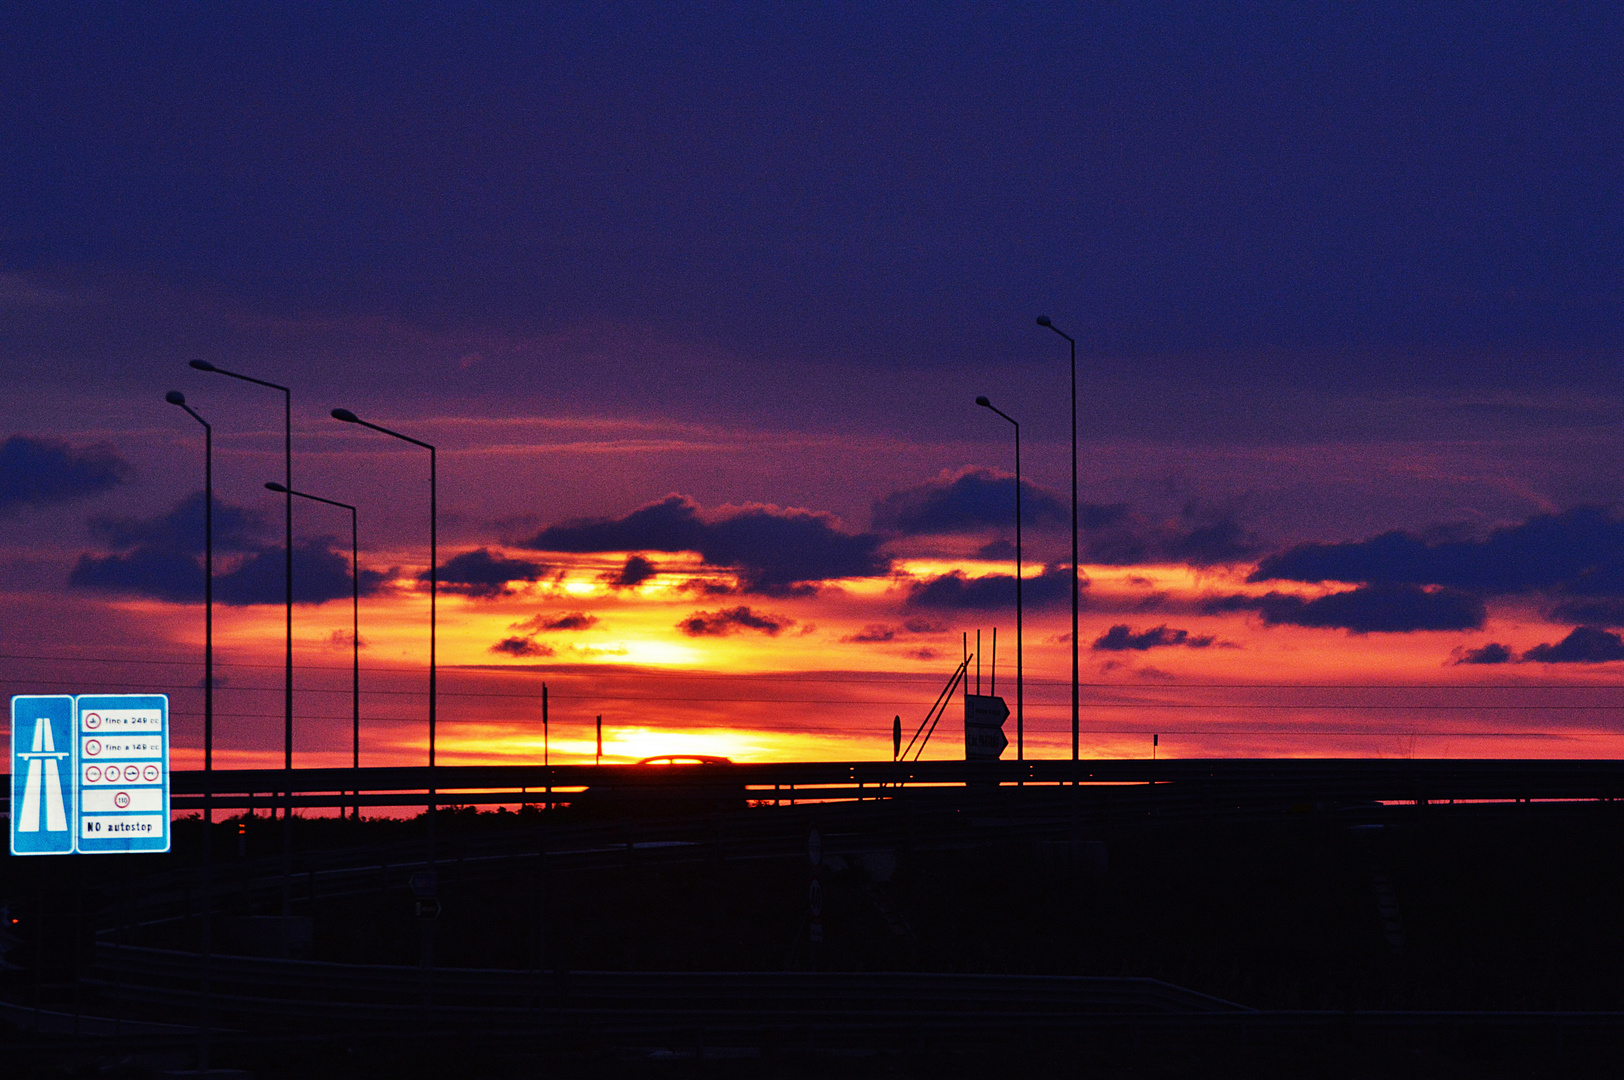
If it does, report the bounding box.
[0,3,1624,767]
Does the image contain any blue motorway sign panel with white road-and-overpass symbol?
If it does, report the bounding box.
[11,695,76,854]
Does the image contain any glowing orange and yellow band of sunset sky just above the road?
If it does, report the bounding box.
[92,535,1619,767]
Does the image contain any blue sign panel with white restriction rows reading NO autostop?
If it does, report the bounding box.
[75,693,169,854]
